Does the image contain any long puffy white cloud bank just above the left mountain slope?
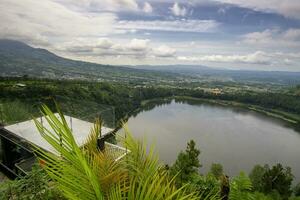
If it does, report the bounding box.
[56,38,176,59]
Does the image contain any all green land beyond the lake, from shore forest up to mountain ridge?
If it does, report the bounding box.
[0,40,300,127]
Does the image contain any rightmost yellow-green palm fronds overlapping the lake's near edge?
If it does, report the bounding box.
[123,126,198,200]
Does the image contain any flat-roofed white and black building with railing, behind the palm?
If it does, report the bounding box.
[0,114,130,178]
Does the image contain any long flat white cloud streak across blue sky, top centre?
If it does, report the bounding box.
[116,20,219,33]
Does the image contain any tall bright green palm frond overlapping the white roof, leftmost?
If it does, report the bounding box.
[35,105,103,199]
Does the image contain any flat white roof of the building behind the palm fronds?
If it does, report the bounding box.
[4,114,113,154]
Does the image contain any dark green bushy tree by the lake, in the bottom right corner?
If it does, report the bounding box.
[262,164,293,199]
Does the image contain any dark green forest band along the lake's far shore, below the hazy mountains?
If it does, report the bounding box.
[0,77,300,126]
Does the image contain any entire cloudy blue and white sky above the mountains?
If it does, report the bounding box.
[0,0,300,71]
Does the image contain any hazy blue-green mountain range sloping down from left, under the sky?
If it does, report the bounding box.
[0,39,300,84]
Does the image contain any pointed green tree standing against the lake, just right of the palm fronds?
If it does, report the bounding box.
[171,140,201,185]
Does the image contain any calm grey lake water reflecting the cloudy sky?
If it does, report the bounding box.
[120,101,300,181]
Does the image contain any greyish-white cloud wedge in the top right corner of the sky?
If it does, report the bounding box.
[215,0,300,19]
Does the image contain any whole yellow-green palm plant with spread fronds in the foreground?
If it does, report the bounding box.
[35,105,205,200]
